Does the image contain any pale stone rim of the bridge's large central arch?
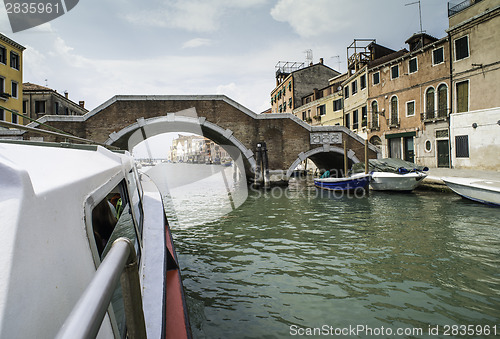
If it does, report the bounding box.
[105,109,256,175]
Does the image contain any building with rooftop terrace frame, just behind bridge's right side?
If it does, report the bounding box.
[271,58,340,115]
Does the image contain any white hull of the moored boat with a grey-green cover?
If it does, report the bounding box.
[370,172,427,191]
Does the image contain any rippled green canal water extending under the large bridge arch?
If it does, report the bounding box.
[148,164,500,338]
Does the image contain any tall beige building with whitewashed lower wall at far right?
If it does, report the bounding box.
[447,0,500,171]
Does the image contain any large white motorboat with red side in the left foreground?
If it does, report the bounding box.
[0,141,191,338]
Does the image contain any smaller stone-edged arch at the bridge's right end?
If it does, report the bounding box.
[286,144,360,178]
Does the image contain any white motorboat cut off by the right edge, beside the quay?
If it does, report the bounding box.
[441,177,500,207]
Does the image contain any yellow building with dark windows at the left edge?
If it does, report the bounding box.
[0,33,25,128]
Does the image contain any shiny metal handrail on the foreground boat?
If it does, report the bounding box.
[56,238,146,339]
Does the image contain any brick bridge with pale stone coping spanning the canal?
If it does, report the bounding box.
[14,95,377,182]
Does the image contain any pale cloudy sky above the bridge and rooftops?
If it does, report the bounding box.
[0,0,448,113]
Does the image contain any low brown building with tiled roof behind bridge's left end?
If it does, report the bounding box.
[22,82,88,120]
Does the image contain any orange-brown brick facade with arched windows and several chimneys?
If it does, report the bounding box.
[368,33,450,167]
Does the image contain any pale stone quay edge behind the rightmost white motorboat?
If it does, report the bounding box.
[417,168,500,191]
